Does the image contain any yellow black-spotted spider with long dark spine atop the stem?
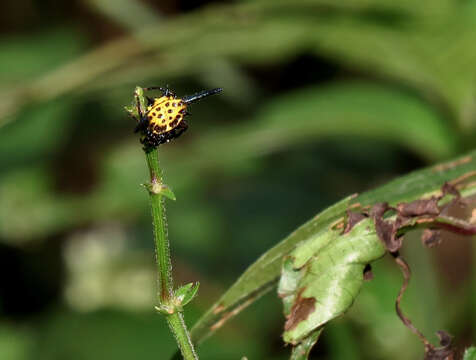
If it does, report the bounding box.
[135,87,222,151]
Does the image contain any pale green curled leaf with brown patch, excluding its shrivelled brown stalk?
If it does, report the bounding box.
[278,218,386,345]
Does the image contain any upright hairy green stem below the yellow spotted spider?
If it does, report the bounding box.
[146,149,198,360]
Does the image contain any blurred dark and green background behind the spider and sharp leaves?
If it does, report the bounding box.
[0,0,476,360]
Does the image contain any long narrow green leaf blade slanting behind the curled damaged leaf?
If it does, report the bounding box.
[188,151,476,341]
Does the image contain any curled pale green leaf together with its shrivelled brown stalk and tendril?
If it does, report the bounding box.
[278,174,476,354]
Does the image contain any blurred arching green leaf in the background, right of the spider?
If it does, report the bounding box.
[245,82,457,159]
